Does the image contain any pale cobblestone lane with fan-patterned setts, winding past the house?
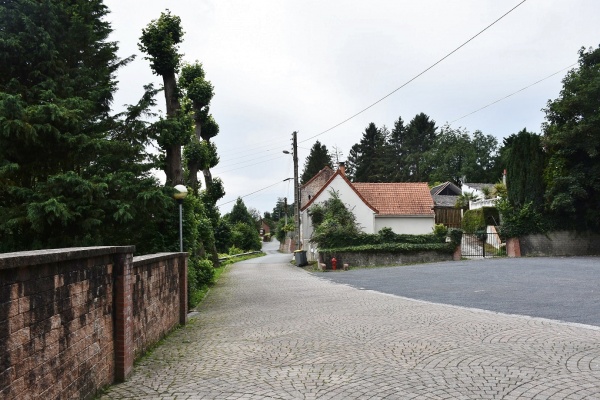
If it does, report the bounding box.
[101,244,600,400]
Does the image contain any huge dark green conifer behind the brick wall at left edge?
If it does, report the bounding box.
[0,0,176,253]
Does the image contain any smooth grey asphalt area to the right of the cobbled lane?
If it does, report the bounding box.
[317,257,600,326]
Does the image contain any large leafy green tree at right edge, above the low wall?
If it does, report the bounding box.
[544,47,600,228]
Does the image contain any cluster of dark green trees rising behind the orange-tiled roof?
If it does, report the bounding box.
[346,113,501,184]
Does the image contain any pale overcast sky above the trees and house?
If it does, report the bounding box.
[105,0,600,214]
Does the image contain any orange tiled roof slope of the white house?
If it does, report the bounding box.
[353,182,434,215]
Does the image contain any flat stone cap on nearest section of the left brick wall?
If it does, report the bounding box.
[0,246,135,269]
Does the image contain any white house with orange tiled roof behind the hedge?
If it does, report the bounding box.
[301,163,435,249]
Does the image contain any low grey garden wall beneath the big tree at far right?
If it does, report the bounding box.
[519,231,600,256]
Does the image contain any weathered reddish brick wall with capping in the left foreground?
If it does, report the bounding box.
[0,246,187,399]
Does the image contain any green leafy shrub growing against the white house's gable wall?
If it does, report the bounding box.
[308,190,360,247]
